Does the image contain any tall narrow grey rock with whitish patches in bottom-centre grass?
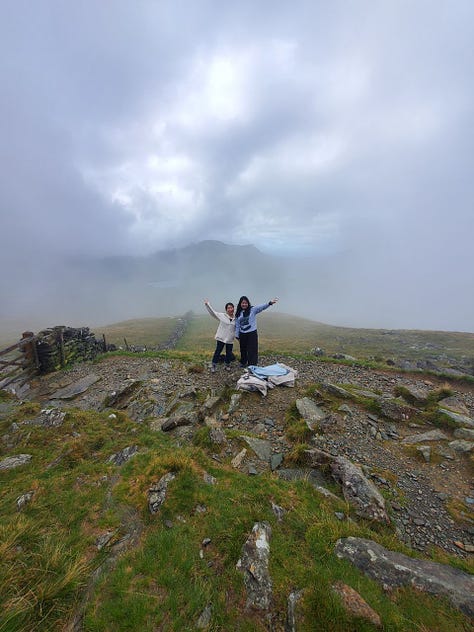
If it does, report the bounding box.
[237,522,273,611]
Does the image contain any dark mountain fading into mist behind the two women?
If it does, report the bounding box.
[0,241,317,329]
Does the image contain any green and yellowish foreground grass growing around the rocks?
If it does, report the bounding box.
[0,396,469,632]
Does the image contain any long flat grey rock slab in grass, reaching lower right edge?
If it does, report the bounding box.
[335,537,474,617]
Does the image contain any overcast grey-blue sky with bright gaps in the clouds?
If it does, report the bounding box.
[0,0,474,331]
